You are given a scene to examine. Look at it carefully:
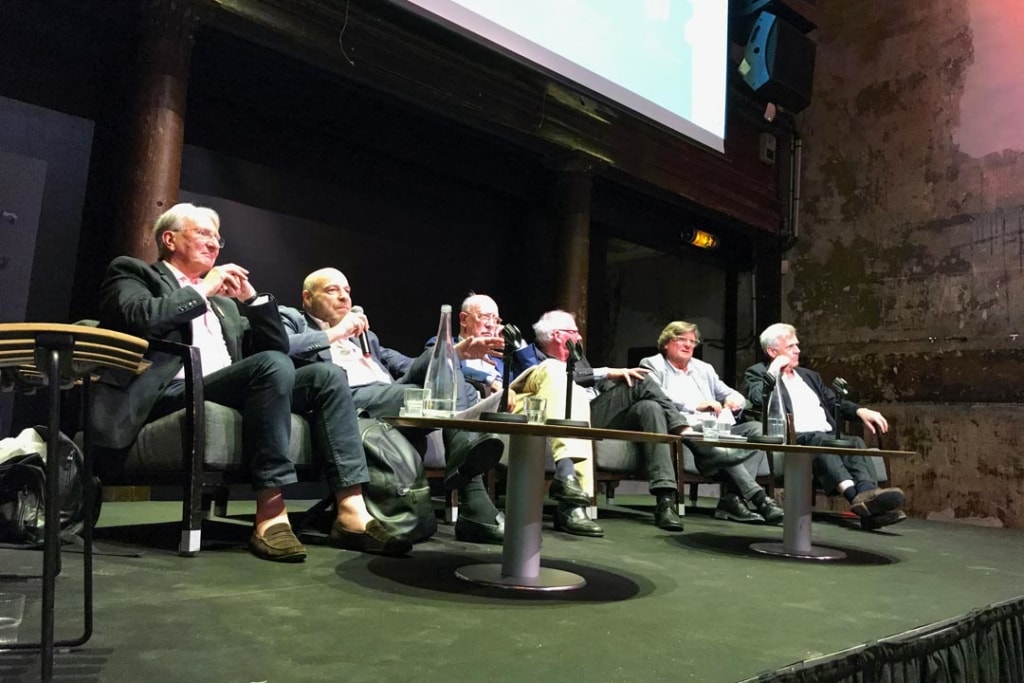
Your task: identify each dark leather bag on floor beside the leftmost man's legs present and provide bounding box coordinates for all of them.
[359,418,437,543]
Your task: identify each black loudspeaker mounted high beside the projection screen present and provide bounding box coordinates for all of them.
[740,12,816,112]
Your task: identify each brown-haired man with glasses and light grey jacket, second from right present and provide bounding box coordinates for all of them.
[640,321,782,524]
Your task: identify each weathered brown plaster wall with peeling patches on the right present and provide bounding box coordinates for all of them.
[783,0,1024,527]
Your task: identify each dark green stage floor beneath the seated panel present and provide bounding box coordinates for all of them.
[0,497,1024,683]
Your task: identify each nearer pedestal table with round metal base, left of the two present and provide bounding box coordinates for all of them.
[384,417,679,591]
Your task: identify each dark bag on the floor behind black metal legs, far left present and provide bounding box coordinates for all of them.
[0,426,98,546]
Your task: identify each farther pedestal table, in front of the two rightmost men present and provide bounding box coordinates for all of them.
[683,434,915,560]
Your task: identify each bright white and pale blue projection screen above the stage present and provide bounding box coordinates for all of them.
[394,0,728,152]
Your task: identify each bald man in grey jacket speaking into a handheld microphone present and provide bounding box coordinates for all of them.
[280,268,505,544]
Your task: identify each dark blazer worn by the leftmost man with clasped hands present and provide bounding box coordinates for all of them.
[92,256,288,449]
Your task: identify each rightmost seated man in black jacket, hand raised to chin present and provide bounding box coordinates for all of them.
[745,323,906,529]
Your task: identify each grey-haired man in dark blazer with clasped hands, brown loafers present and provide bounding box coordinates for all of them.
[92,204,411,561]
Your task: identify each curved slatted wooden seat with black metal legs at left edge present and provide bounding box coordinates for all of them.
[0,323,150,681]
